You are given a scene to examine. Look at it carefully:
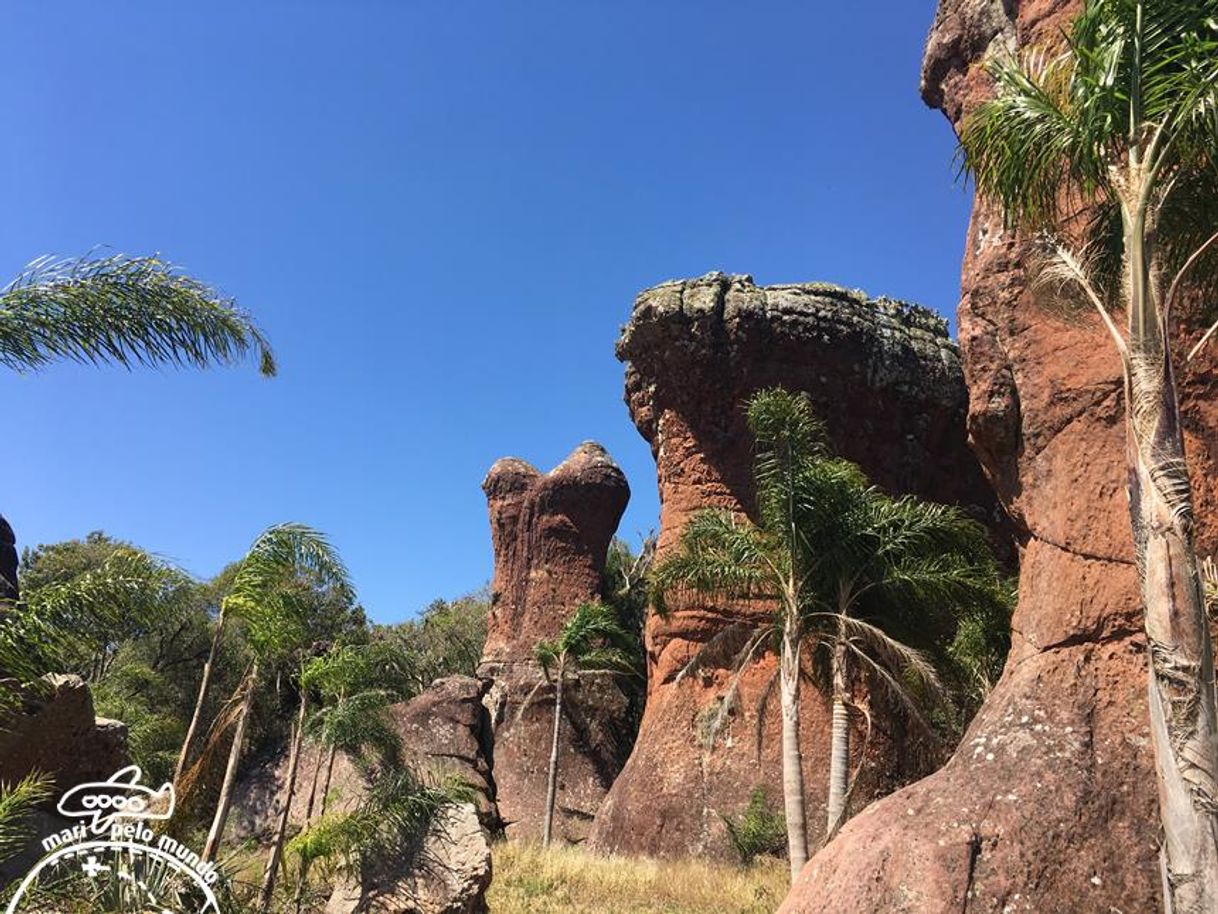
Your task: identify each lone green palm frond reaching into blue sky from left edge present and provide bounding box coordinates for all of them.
[0,255,275,377]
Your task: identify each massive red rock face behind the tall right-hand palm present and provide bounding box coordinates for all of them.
[782,0,1218,914]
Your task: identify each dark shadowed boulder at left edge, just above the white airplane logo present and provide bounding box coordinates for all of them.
[0,673,130,792]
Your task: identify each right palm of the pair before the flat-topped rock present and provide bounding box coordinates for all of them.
[800,473,1002,841]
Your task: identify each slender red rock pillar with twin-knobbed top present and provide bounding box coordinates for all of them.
[479,441,630,841]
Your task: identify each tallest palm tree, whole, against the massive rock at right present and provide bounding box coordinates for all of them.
[960,0,1218,912]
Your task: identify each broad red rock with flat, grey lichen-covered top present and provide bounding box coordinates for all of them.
[592,273,1001,856]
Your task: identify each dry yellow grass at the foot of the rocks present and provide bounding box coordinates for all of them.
[487,842,788,914]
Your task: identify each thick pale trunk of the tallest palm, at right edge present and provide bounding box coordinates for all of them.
[1125,339,1218,914]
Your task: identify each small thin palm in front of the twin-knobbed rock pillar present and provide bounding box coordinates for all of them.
[531,603,632,847]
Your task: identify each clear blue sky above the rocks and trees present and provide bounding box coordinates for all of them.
[0,0,968,622]
